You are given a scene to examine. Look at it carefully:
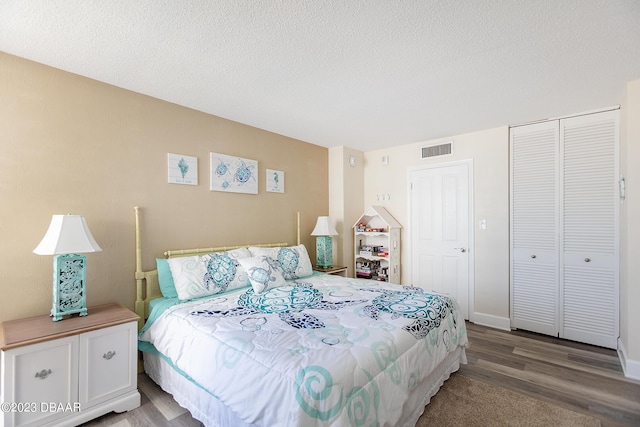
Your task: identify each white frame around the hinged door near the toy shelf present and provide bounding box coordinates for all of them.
[407,159,475,322]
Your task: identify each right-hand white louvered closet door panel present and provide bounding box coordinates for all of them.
[560,111,619,348]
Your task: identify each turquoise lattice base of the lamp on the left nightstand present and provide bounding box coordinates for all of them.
[51,254,87,321]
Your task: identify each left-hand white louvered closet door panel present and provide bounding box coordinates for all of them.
[510,121,560,336]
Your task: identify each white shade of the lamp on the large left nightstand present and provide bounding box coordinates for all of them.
[33,215,102,255]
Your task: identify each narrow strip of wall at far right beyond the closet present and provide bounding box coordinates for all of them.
[619,80,640,380]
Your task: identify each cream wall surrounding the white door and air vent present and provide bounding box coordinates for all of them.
[356,127,509,328]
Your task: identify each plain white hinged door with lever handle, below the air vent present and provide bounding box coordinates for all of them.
[410,164,470,319]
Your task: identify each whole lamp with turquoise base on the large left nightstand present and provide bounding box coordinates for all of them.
[33,215,102,321]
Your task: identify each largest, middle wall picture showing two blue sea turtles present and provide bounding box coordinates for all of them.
[210,153,258,194]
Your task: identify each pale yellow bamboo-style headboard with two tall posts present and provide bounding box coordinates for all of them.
[133,206,300,329]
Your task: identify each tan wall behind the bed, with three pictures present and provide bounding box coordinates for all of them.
[0,53,329,320]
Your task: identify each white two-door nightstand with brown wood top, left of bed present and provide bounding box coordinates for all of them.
[0,304,140,427]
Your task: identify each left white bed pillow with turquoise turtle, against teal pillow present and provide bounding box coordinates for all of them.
[168,248,251,300]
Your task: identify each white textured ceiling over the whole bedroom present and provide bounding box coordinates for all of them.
[0,0,640,151]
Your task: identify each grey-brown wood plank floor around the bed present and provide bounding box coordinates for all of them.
[85,323,640,427]
